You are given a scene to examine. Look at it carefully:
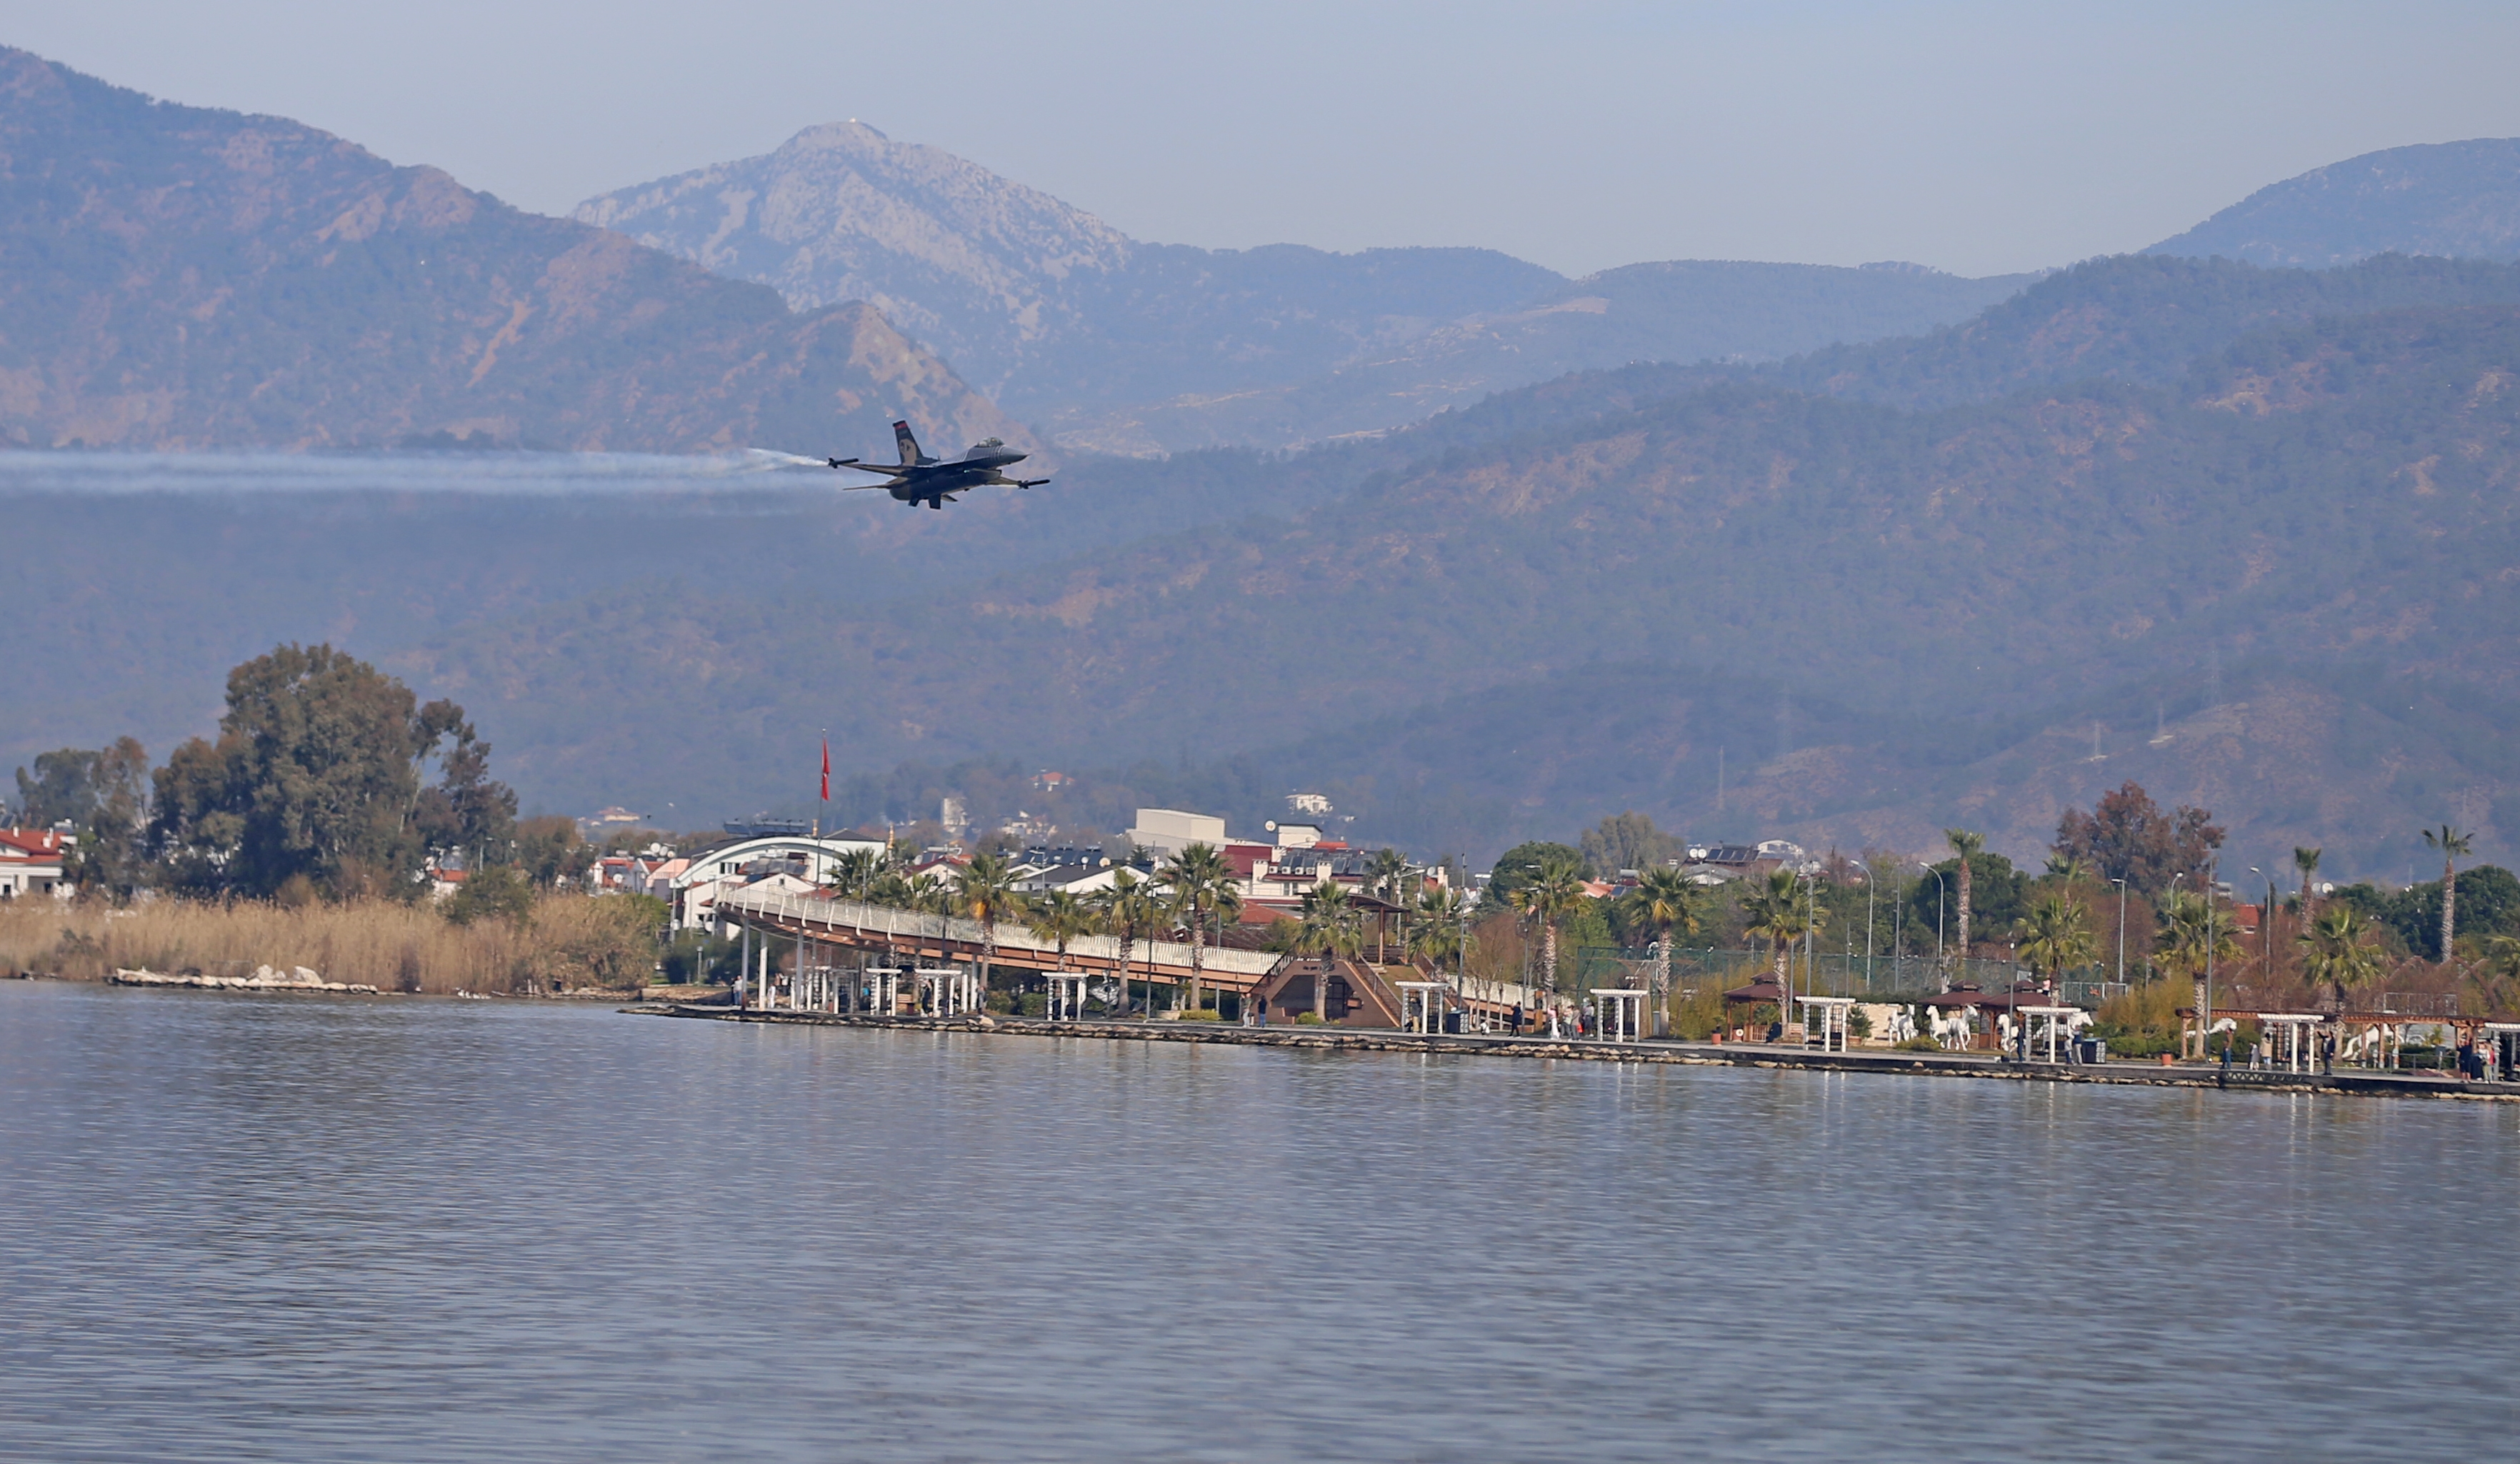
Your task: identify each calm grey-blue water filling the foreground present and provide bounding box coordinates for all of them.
[0,983,2520,1461]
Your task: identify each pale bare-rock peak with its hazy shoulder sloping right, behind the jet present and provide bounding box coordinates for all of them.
[574,121,1560,413]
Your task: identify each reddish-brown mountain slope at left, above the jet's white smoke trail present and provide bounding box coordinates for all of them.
[0,51,1023,451]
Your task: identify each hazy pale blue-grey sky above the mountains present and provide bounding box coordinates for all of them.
[0,0,2520,275]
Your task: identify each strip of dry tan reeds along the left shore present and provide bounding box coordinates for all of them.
[0,895,655,996]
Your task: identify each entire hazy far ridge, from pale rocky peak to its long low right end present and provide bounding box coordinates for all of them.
[574,121,2031,456]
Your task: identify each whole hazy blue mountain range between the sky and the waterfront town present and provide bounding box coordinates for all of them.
[0,40,2520,877]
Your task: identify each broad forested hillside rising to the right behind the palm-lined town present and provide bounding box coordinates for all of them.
[360,294,2520,857]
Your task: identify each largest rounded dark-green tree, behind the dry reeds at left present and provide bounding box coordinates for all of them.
[149,645,514,897]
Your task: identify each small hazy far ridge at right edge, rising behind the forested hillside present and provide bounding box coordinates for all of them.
[2144,136,2520,270]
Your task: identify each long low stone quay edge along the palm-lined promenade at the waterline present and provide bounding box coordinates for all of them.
[622,1003,2520,1103]
